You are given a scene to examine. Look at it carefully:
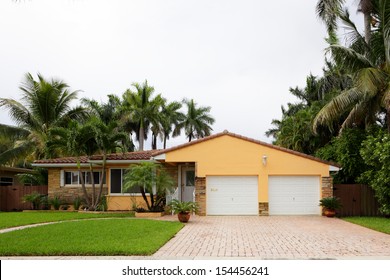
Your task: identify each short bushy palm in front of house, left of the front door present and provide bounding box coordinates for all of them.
[124,162,175,211]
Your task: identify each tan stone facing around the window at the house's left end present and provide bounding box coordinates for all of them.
[48,168,107,204]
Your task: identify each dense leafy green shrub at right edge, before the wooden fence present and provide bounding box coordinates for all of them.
[360,130,390,215]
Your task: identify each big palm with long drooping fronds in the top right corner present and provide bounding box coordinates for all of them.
[313,0,390,131]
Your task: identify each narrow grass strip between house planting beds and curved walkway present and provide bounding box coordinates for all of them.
[0,211,134,229]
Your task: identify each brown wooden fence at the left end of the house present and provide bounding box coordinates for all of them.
[0,186,47,211]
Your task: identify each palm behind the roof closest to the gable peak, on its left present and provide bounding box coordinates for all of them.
[179,99,215,142]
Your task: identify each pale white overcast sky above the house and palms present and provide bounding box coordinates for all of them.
[0,0,362,148]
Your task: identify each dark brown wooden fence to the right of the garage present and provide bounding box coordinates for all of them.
[333,184,381,217]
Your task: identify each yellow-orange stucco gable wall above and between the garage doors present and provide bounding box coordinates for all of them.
[165,135,329,202]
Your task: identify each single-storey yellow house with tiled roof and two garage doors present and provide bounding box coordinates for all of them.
[34,131,339,215]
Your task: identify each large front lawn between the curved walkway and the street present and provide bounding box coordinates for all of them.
[0,218,183,256]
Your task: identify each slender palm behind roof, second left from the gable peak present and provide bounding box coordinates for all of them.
[161,101,185,149]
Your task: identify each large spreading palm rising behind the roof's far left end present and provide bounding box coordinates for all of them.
[0,73,86,159]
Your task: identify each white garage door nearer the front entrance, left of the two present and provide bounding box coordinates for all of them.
[206,176,259,215]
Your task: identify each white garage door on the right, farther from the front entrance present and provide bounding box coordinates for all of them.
[268,176,321,215]
